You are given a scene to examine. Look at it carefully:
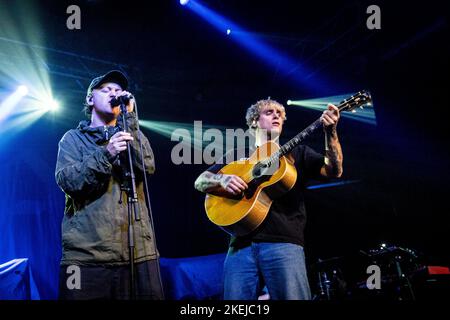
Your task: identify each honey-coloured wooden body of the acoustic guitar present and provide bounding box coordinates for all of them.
[205,141,297,236]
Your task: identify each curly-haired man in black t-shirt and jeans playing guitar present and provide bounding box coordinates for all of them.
[195,99,343,300]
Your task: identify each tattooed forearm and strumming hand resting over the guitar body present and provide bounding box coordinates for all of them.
[195,171,248,197]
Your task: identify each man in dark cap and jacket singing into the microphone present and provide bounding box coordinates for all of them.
[55,70,163,300]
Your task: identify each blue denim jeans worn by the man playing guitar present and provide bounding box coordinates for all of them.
[224,242,311,300]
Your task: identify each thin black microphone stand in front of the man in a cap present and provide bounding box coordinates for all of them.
[120,101,141,300]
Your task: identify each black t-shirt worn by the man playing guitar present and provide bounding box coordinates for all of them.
[207,145,324,247]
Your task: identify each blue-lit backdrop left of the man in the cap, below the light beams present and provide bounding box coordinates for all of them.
[0,128,64,299]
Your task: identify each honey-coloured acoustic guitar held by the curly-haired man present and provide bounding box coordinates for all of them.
[205,91,372,236]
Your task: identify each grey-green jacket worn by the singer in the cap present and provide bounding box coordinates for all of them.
[55,113,157,265]
